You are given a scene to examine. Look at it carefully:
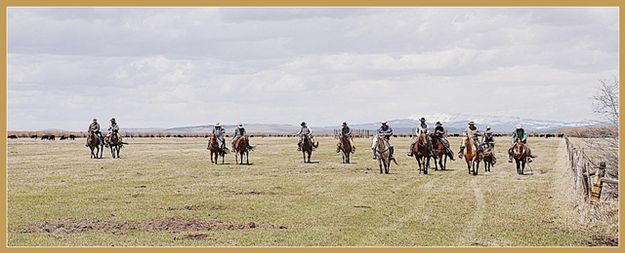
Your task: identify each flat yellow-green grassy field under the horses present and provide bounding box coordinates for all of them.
[8,138,617,246]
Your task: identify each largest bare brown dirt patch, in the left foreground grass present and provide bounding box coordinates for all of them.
[21,217,286,234]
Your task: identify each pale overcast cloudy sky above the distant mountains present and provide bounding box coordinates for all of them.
[7,8,618,130]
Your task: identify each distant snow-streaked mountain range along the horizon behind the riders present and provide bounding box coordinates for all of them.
[121,113,602,134]
